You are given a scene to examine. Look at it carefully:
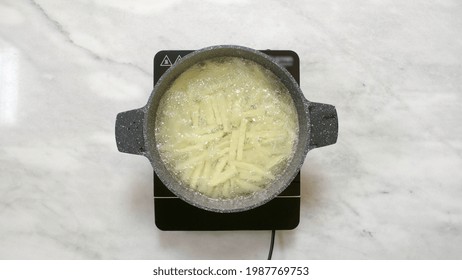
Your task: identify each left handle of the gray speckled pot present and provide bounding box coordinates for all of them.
[115,108,146,155]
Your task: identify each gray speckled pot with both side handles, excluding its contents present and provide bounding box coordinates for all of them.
[115,46,338,212]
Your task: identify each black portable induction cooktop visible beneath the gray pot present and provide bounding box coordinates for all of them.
[154,50,300,231]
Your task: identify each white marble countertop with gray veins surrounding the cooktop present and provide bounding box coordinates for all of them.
[0,0,462,259]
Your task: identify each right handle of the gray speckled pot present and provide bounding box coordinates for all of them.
[306,101,338,149]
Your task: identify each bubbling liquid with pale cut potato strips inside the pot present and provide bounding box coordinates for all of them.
[155,57,298,199]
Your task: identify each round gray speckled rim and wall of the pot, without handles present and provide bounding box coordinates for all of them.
[143,45,310,213]
